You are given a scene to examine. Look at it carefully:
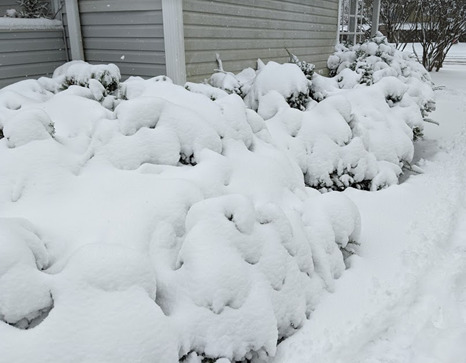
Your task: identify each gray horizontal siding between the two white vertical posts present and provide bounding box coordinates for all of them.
[73,0,165,78]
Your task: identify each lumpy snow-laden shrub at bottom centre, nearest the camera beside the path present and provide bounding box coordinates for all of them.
[152,195,359,361]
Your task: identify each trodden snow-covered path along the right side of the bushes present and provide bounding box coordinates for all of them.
[274,65,466,363]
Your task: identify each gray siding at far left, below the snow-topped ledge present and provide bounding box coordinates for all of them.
[0,29,66,87]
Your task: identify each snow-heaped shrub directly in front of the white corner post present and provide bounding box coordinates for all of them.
[103,81,253,168]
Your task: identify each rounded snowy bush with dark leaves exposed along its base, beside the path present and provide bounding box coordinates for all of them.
[267,86,413,191]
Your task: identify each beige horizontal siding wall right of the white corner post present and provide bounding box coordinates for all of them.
[183,0,338,81]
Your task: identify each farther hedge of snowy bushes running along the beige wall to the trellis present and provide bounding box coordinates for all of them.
[204,35,435,191]
